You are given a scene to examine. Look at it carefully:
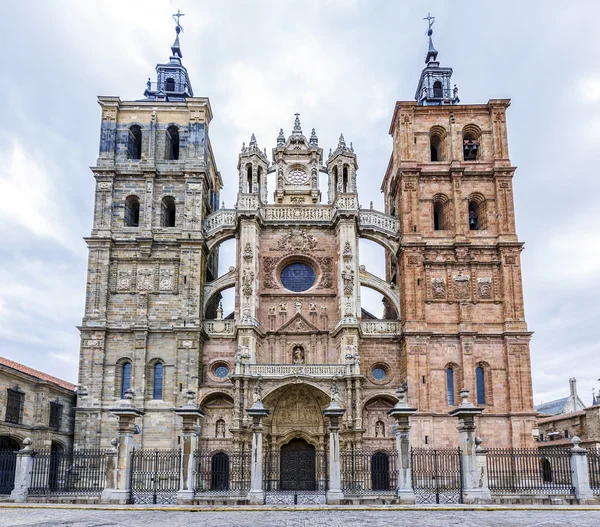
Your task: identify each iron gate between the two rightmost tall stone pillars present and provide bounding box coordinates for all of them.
[411,448,463,503]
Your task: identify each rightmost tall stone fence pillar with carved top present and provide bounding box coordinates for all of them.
[450,388,492,503]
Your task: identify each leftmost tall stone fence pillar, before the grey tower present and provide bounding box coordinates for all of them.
[108,390,144,504]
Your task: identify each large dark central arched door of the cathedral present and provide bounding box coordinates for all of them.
[280,439,317,490]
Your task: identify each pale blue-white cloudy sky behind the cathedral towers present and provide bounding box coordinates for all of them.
[0,0,600,403]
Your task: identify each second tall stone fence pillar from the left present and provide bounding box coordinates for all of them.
[175,390,205,503]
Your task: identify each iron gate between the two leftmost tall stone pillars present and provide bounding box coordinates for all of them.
[131,448,181,505]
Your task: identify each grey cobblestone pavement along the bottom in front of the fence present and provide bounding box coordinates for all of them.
[0,507,600,527]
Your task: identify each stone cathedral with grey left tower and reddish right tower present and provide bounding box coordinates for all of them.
[75,18,535,450]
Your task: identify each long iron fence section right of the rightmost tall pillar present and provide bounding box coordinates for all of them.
[487,448,575,494]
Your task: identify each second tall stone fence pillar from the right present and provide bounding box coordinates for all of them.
[388,384,417,503]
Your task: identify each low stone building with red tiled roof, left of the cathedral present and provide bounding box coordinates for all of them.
[0,357,76,450]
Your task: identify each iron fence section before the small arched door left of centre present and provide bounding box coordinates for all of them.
[194,450,252,496]
